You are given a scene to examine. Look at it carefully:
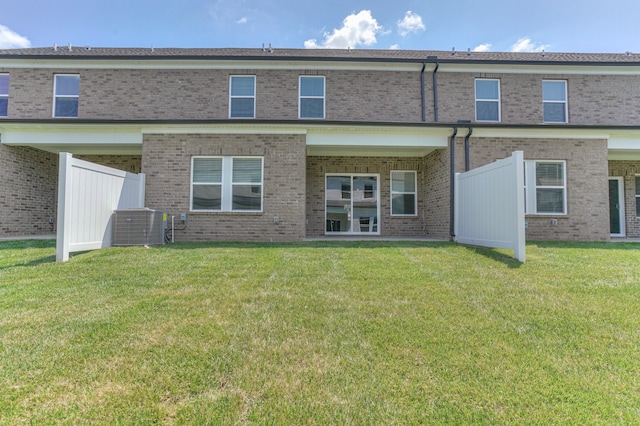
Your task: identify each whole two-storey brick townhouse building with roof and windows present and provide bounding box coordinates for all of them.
[0,46,640,241]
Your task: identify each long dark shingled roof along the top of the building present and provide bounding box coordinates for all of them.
[0,45,640,65]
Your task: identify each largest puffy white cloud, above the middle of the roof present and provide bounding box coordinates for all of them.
[304,10,383,49]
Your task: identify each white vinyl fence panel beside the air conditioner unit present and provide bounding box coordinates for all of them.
[56,152,145,262]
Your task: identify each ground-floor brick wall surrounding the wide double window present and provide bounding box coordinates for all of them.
[142,134,306,241]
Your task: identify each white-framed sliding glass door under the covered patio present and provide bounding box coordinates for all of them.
[325,174,380,234]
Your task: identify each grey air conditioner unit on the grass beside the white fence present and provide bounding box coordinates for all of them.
[113,208,167,246]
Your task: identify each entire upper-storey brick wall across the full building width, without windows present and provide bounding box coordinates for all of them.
[6,68,640,125]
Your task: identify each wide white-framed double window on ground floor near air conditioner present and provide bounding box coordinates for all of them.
[191,157,263,212]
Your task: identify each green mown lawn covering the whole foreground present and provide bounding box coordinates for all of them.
[0,241,640,425]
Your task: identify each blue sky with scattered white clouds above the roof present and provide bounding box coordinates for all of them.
[0,0,640,53]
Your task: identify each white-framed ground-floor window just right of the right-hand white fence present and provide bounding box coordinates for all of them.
[524,160,567,215]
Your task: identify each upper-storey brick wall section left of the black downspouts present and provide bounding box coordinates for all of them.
[0,69,422,121]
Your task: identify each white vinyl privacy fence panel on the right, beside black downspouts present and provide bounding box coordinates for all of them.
[454,151,525,262]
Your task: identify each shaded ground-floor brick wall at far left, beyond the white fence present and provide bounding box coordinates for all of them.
[0,144,58,237]
